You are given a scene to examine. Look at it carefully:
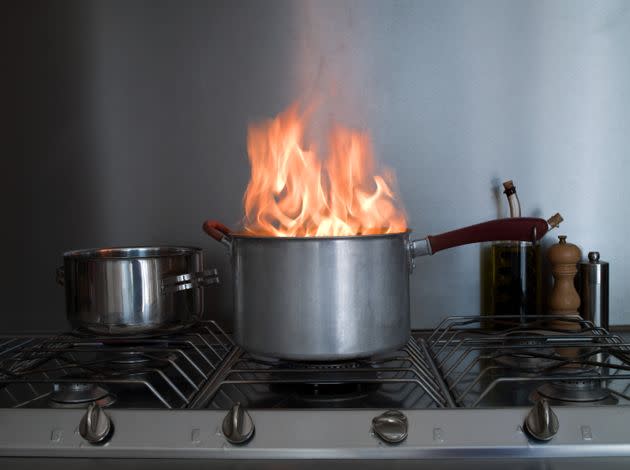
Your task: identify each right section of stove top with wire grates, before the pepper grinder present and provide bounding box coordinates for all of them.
[426,316,630,408]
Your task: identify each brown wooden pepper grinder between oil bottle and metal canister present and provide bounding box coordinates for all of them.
[547,235,582,331]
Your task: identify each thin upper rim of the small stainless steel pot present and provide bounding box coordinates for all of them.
[63,245,202,260]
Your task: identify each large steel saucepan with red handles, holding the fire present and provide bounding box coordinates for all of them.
[203,218,548,361]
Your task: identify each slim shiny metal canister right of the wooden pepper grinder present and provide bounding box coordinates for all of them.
[580,251,609,329]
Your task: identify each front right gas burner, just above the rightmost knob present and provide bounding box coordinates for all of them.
[531,369,619,405]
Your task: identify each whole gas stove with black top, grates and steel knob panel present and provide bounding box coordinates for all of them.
[0,316,630,468]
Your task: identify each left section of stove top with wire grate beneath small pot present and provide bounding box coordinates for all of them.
[0,322,234,408]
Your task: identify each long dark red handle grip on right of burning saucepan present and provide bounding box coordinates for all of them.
[427,217,548,253]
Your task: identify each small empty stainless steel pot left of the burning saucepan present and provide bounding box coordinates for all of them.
[57,246,219,335]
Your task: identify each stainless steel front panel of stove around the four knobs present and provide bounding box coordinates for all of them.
[6,406,630,460]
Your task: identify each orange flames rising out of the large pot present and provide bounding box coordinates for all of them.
[244,104,407,237]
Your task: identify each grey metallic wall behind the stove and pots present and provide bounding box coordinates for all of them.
[0,0,630,331]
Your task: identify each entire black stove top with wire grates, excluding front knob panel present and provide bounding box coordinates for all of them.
[0,316,630,410]
